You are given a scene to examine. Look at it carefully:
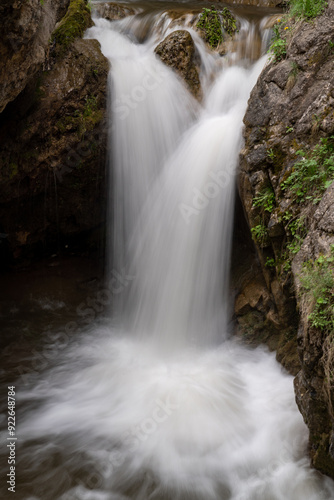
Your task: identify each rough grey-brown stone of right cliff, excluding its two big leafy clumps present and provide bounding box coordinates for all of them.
[237,1,334,478]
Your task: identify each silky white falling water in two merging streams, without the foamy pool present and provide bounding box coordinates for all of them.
[85,14,264,351]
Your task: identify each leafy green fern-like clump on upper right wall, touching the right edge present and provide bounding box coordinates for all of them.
[281,136,334,204]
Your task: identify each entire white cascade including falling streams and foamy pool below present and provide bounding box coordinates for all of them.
[3,4,334,500]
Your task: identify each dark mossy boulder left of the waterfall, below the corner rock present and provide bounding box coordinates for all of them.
[0,2,109,266]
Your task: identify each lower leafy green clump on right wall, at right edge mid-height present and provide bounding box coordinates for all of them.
[300,245,334,333]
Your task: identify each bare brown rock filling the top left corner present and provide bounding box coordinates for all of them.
[0,0,70,113]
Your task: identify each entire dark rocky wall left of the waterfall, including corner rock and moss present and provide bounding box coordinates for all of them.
[0,0,109,266]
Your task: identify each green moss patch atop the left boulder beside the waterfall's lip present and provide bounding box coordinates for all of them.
[51,0,92,57]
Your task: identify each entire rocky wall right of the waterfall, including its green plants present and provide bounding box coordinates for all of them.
[236,1,334,478]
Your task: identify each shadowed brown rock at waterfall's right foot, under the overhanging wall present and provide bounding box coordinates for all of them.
[231,195,301,375]
